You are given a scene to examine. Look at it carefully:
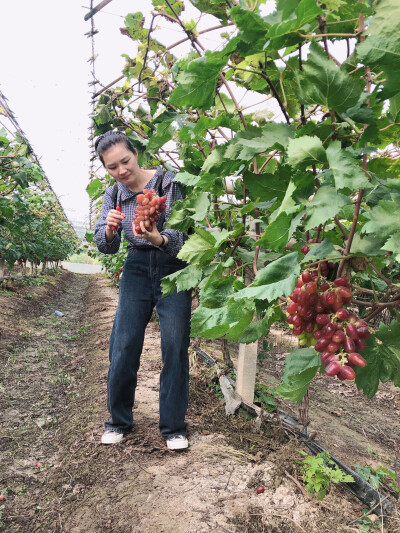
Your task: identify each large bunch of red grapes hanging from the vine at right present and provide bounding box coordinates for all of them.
[287,270,370,380]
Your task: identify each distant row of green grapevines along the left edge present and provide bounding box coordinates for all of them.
[0,108,79,278]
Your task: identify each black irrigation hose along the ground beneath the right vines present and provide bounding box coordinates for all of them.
[194,346,393,515]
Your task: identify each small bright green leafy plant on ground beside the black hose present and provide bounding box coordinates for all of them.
[300,450,354,501]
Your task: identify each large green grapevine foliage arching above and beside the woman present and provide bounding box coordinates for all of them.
[88,0,400,400]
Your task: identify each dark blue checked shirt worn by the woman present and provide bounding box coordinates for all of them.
[94,168,187,257]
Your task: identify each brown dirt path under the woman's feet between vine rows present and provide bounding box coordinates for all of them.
[0,272,396,533]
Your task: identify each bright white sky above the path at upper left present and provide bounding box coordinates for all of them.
[0,0,288,229]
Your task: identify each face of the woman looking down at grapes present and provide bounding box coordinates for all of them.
[102,143,139,188]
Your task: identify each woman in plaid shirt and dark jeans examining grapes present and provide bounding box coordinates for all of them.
[94,132,191,450]
